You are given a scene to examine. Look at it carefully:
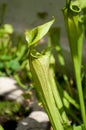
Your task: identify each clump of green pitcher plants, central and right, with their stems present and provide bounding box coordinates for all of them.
[26,0,86,130]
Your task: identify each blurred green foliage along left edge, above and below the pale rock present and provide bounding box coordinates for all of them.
[0,4,32,130]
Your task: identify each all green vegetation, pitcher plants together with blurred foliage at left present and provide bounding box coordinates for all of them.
[0,0,86,130]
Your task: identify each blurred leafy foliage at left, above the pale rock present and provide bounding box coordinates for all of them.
[0,24,30,89]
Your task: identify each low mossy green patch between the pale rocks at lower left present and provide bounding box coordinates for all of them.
[0,100,29,120]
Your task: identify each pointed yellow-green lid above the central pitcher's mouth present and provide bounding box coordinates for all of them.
[26,19,55,47]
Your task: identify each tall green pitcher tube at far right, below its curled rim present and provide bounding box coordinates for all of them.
[63,2,86,128]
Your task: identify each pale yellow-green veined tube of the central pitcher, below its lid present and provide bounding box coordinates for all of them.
[30,50,64,130]
